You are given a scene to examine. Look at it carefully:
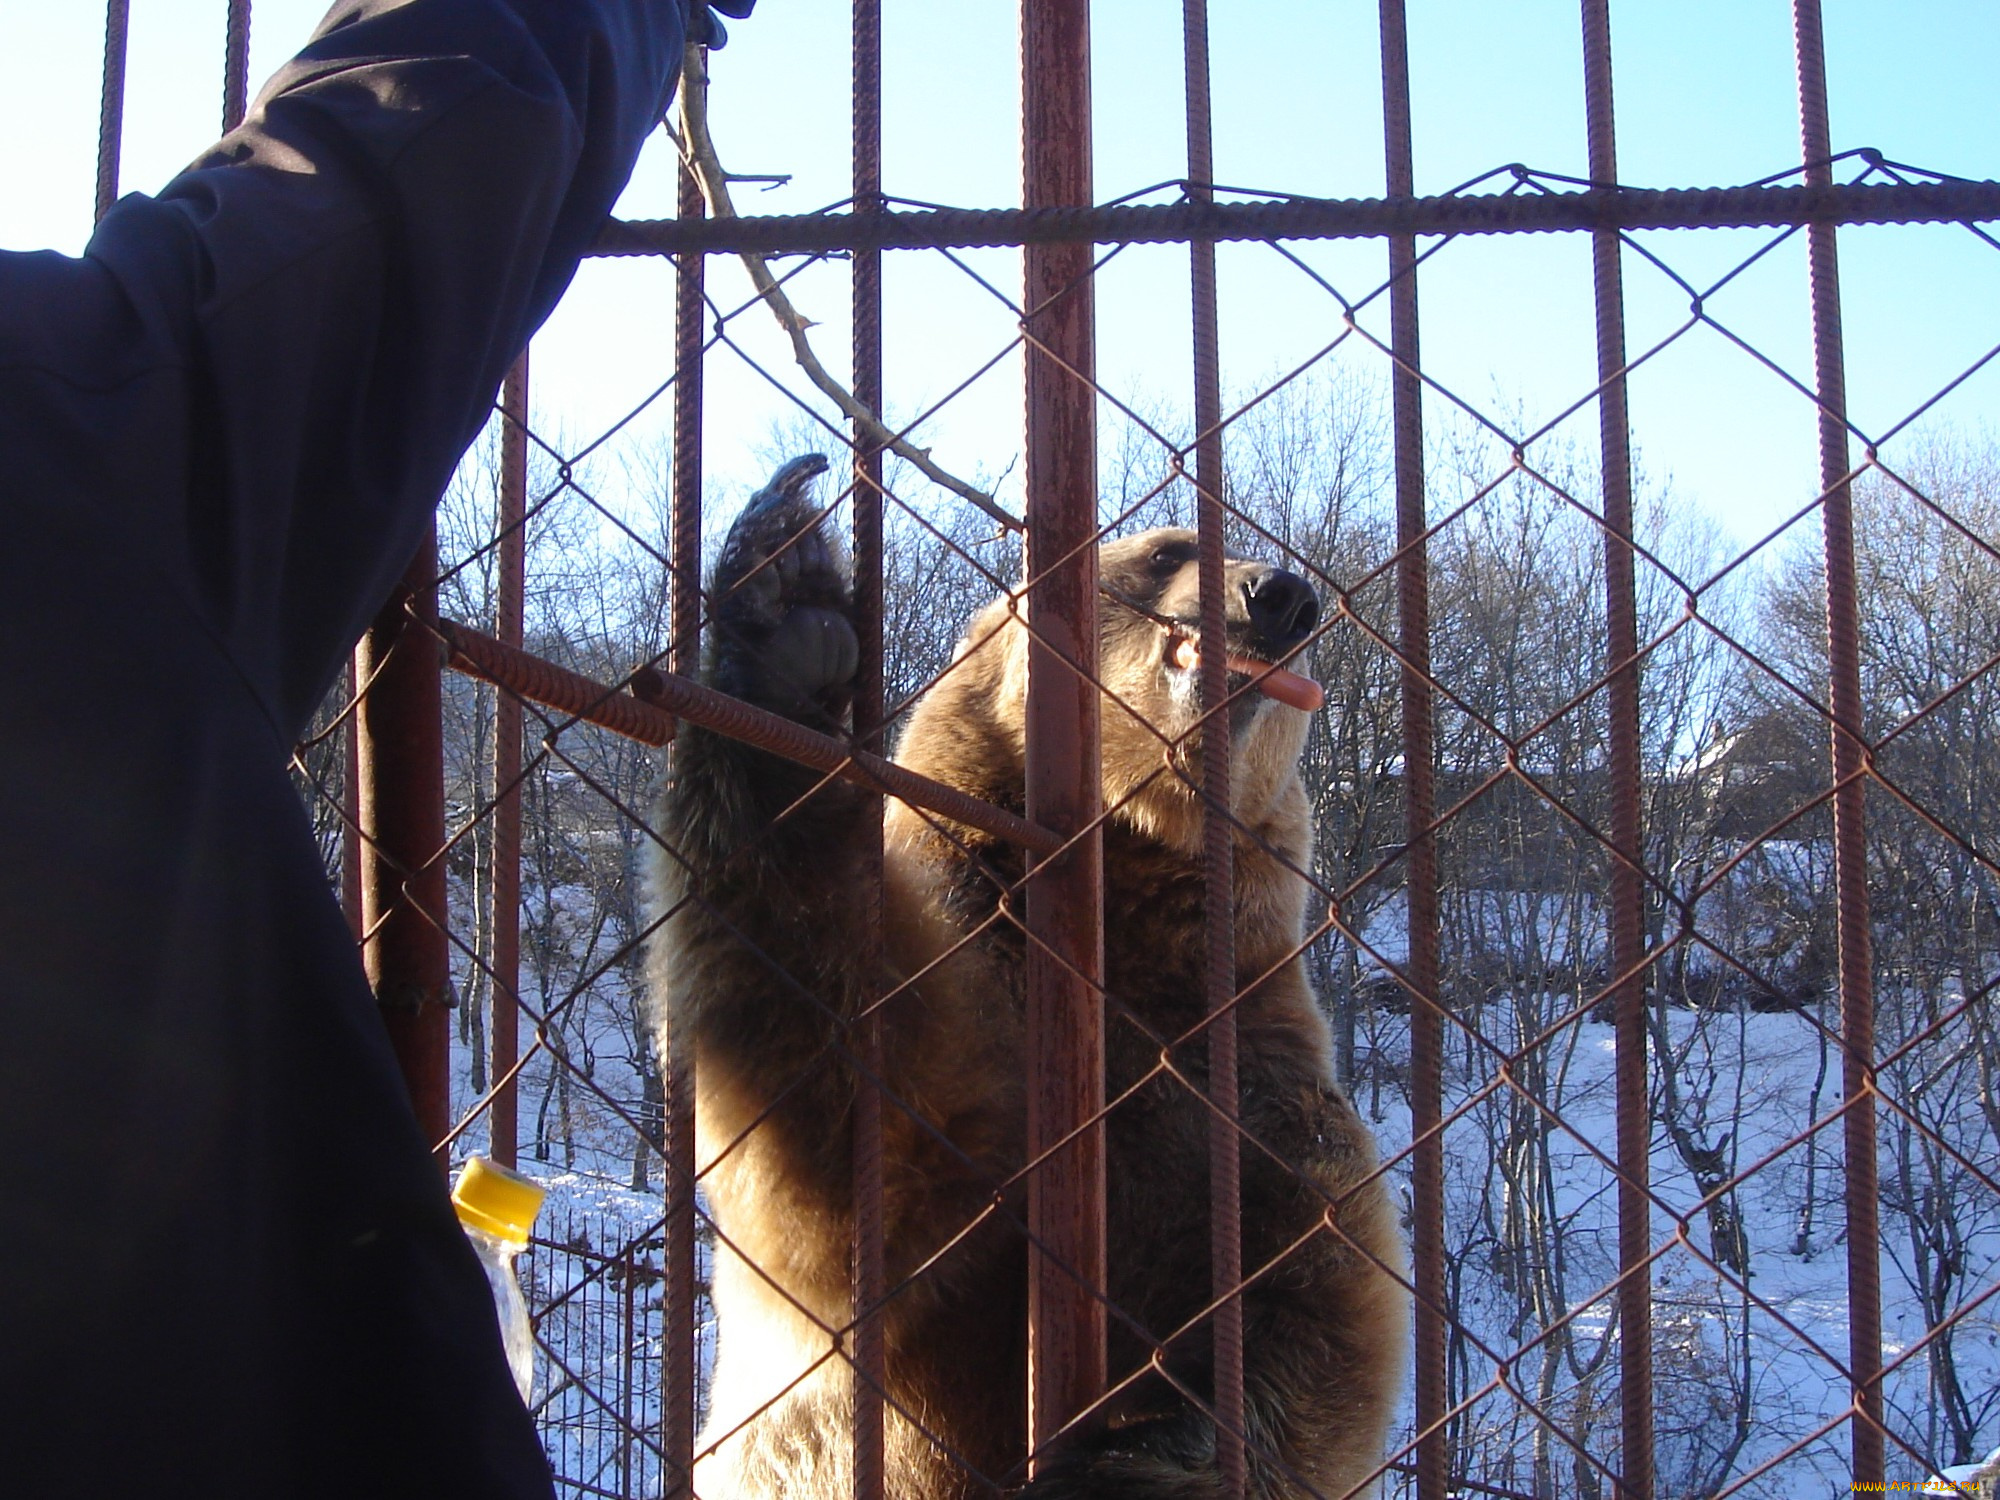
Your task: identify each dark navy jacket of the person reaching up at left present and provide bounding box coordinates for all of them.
[0,0,684,1500]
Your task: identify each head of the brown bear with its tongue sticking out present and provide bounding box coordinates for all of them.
[898,528,1320,852]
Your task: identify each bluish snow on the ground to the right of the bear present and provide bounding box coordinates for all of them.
[1356,996,2000,1496]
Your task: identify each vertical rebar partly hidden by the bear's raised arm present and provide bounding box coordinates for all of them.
[660,114,706,1500]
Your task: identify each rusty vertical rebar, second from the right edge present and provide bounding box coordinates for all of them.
[1584,0,1654,1500]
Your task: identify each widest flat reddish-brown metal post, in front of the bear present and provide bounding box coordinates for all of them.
[1020,0,1106,1470]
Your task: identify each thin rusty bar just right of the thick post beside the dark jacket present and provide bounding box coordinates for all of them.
[486,350,528,1166]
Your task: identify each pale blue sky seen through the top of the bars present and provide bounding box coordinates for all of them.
[0,0,2000,560]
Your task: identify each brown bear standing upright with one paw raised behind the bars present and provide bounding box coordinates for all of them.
[650,456,1408,1500]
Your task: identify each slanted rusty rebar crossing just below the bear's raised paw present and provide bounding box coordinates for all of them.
[436,620,1062,854]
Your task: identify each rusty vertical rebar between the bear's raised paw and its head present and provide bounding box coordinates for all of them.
[852,0,888,1500]
